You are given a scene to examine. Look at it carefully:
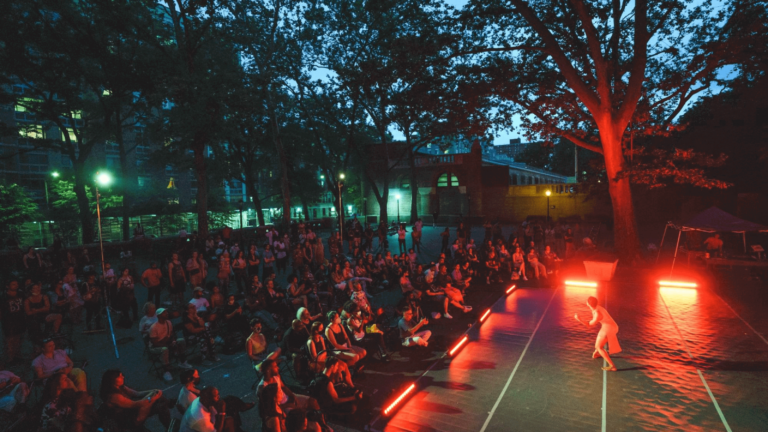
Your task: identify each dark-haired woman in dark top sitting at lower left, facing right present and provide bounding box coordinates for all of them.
[99,369,171,429]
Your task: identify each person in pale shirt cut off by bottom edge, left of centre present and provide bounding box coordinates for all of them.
[179,387,235,432]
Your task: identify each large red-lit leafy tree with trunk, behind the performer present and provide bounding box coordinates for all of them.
[456,0,750,262]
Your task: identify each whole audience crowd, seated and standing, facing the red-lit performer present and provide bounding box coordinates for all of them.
[0,218,591,432]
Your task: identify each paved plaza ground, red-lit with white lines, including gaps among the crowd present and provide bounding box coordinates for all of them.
[6,227,768,431]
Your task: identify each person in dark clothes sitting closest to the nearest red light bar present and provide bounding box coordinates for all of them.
[309,356,363,415]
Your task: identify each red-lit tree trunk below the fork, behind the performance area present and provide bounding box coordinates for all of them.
[600,124,640,264]
